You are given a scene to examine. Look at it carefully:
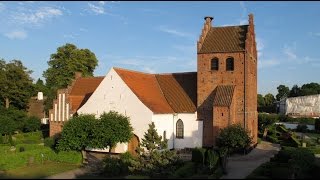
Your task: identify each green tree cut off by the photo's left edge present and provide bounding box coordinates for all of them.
[0,59,33,109]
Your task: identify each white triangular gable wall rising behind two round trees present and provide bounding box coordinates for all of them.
[77,68,153,153]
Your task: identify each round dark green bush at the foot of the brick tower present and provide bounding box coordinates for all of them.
[217,124,252,153]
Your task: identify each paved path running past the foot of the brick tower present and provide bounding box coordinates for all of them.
[221,141,280,179]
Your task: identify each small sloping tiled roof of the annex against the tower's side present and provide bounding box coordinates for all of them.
[213,85,235,106]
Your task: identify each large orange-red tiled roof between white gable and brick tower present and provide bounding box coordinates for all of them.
[114,68,197,114]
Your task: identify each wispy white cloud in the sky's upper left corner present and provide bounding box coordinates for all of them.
[13,7,63,25]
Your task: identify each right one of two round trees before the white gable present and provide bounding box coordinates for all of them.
[91,111,133,152]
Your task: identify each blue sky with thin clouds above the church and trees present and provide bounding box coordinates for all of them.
[0,1,320,95]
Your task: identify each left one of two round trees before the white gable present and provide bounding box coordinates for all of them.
[57,115,96,151]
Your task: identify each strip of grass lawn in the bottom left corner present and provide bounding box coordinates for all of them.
[0,161,80,179]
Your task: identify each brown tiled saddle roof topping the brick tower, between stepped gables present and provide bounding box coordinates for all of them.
[198,25,248,53]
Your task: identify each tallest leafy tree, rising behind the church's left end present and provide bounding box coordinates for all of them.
[43,43,98,112]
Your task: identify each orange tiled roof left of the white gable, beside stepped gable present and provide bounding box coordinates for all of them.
[69,77,104,112]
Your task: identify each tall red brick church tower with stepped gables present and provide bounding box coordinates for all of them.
[197,14,258,147]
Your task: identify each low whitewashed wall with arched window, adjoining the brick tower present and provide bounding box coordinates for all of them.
[152,113,203,149]
